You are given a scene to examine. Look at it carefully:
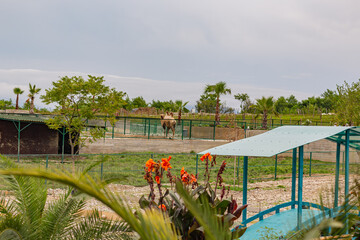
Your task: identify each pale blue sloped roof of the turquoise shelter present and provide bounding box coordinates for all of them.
[199,126,360,157]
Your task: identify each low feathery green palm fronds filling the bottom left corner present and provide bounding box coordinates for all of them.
[0,172,129,240]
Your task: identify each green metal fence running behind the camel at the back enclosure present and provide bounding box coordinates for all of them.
[84,117,331,140]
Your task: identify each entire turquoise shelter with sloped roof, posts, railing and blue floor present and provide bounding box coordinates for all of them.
[199,126,360,240]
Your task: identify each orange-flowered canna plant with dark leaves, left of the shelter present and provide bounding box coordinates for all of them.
[139,155,247,239]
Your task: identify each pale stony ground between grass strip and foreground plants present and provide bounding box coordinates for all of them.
[43,172,355,221]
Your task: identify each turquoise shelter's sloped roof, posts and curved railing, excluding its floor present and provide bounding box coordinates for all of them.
[199,126,360,237]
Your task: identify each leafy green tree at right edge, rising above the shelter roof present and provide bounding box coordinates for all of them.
[336,80,360,126]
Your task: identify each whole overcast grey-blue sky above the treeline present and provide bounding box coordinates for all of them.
[0,0,360,109]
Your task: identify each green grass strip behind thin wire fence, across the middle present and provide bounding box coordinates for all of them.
[0,152,358,189]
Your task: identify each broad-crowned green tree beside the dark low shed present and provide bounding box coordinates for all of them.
[41,75,124,168]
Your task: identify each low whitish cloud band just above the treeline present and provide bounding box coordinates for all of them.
[0,69,310,108]
